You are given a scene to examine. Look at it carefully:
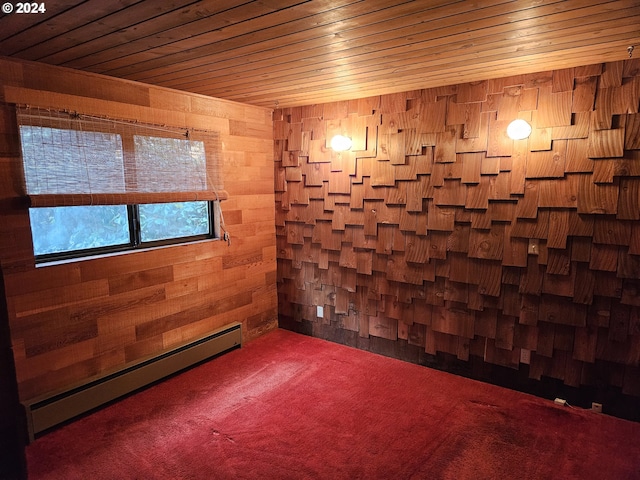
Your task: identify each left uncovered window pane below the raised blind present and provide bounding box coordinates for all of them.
[29,205,130,255]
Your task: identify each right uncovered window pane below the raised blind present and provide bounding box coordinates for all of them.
[139,201,210,242]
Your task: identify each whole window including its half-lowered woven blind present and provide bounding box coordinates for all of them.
[18,109,224,262]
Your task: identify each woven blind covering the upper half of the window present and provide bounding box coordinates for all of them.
[17,107,226,207]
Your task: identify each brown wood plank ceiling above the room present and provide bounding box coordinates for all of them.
[0,0,640,108]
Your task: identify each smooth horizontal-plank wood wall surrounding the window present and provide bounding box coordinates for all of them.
[0,59,277,400]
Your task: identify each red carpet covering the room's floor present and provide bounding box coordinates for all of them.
[27,330,640,480]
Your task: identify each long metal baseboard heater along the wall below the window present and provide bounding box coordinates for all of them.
[23,322,242,441]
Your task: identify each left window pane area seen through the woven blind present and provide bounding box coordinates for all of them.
[20,125,125,195]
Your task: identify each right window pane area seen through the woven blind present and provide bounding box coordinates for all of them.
[133,135,207,192]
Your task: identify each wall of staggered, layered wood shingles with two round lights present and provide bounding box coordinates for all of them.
[274,59,640,396]
